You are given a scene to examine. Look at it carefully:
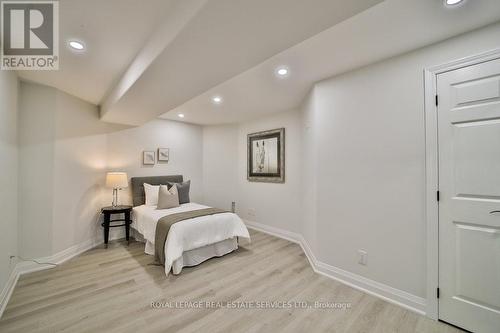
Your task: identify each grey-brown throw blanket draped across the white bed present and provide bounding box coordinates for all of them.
[155,208,227,266]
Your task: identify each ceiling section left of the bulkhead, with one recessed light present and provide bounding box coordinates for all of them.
[18,0,173,104]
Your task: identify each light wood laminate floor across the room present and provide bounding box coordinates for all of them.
[0,231,459,333]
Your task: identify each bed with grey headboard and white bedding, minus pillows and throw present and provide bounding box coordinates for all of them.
[131,175,250,276]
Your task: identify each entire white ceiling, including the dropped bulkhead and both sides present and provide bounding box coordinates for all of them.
[13,0,500,125]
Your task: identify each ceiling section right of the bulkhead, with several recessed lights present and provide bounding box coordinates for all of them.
[161,0,500,125]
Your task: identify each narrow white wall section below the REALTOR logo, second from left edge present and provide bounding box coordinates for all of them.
[18,82,57,258]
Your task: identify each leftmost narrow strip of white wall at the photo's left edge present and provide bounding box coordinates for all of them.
[0,71,18,292]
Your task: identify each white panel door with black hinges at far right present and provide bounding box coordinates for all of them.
[437,60,500,333]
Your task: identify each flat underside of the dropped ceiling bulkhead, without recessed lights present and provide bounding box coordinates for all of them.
[101,0,381,125]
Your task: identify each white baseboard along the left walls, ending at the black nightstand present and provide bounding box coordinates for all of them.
[0,235,127,318]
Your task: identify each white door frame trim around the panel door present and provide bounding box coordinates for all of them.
[424,49,500,320]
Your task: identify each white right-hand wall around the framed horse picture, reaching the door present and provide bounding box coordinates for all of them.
[203,24,500,298]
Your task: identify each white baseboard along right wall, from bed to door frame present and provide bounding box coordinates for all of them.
[245,220,426,315]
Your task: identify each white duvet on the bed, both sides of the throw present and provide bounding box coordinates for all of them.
[132,202,250,275]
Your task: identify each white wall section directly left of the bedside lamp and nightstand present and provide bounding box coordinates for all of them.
[52,91,112,253]
